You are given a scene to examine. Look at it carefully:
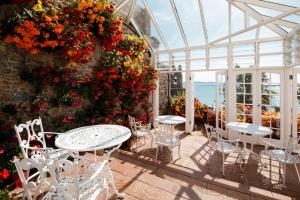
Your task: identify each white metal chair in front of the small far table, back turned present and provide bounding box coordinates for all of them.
[155,124,181,162]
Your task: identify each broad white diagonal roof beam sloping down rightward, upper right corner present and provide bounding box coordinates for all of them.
[231,2,287,38]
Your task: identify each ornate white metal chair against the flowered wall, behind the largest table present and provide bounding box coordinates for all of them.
[15,117,68,160]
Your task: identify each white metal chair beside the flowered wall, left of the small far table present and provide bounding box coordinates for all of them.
[128,115,153,150]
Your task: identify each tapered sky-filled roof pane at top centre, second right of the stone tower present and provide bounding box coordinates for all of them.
[174,0,205,46]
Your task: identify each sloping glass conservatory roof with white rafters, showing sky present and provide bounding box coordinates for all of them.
[114,0,300,51]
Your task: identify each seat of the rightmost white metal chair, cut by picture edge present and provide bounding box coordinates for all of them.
[260,149,300,164]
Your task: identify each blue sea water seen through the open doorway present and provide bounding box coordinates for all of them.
[194,82,216,107]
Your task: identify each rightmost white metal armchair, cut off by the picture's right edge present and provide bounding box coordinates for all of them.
[259,136,300,185]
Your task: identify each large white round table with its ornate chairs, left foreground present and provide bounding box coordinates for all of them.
[14,118,131,200]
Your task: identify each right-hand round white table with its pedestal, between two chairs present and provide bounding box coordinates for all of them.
[227,122,272,159]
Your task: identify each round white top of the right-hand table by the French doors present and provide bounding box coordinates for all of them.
[227,122,272,136]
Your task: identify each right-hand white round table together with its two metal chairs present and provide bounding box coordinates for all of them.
[205,122,300,184]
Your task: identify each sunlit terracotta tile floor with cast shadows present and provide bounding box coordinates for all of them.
[9,126,300,200]
